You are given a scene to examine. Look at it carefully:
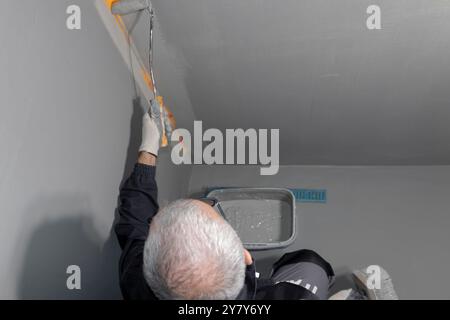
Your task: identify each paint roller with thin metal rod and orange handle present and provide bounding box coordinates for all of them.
[111,0,175,147]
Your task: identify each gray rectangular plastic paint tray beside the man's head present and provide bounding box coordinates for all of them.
[207,188,296,250]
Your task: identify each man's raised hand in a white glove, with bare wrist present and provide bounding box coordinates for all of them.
[138,112,160,165]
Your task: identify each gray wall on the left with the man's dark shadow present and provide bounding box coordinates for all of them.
[0,0,193,299]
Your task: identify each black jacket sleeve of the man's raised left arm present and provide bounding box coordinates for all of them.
[115,164,158,299]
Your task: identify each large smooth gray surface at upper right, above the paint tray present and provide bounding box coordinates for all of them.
[148,0,450,165]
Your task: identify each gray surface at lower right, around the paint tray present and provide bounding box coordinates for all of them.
[190,166,450,299]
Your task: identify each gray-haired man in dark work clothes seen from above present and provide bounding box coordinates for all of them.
[115,113,334,299]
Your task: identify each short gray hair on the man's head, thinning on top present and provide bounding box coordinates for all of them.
[144,200,245,300]
